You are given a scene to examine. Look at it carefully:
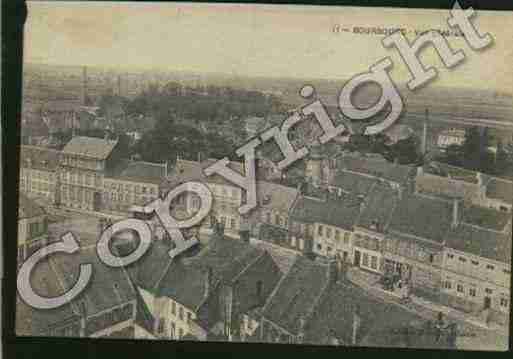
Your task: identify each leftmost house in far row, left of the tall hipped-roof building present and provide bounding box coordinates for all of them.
[19,145,59,204]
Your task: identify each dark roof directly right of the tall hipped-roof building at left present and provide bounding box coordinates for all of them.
[108,160,166,184]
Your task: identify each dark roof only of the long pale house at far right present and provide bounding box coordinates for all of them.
[446,223,511,263]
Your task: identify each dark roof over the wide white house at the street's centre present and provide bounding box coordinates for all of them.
[291,196,360,230]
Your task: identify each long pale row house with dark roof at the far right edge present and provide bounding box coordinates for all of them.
[441,205,511,324]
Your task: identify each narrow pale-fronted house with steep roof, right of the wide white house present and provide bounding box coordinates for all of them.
[350,183,400,274]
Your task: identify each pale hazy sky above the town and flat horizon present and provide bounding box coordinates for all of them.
[25,2,513,93]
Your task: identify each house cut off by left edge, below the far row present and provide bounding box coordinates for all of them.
[18,193,48,265]
